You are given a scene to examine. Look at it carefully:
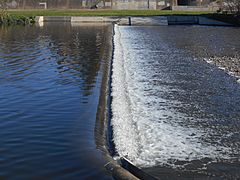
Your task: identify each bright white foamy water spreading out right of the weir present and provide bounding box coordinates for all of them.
[112,26,231,167]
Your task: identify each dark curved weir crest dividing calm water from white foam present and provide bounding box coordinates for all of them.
[95,22,157,180]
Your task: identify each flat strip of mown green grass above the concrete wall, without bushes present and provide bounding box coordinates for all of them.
[8,9,211,17]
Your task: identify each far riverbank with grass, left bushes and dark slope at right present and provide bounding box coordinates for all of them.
[5,9,240,26]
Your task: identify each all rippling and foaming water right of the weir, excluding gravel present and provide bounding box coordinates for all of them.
[112,26,240,177]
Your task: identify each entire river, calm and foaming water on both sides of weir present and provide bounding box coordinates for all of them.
[0,23,240,179]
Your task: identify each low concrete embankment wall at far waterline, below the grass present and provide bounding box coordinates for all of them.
[36,15,231,26]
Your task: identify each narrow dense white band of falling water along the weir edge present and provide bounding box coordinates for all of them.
[112,25,138,160]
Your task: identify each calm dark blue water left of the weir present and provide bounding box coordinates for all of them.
[0,24,109,179]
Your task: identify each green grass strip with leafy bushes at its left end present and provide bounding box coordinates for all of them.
[0,10,208,25]
